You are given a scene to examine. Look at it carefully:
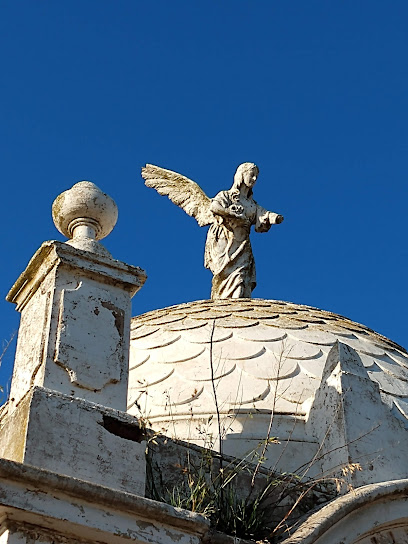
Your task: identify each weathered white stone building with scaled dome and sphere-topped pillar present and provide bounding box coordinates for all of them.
[0,182,408,544]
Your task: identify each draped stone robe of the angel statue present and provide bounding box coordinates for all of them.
[204,190,278,299]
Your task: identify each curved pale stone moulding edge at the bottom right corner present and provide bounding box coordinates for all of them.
[281,479,408,544]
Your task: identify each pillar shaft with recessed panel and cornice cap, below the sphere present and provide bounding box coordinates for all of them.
[8,242,146,410]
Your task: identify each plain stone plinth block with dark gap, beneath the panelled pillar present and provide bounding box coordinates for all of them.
[0,387,146,496]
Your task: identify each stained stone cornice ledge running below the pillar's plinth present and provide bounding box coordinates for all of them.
[0,459,209,544]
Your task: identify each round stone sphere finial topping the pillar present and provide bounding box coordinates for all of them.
[52,181,118,256]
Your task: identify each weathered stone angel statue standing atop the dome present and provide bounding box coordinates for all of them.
[142,162,283,299]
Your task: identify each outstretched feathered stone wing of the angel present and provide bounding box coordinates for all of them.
[142,164,214,227]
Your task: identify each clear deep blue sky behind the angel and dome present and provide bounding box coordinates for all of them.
[0,0,408,398]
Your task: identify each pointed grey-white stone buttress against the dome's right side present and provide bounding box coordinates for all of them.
[306,342,408,486]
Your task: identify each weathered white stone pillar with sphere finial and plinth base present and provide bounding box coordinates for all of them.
[0,181,146,495]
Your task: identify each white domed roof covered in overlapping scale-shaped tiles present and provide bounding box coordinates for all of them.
[129,299,408,421]
